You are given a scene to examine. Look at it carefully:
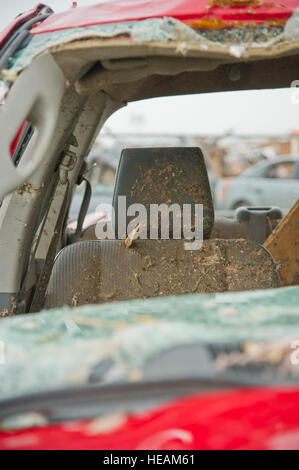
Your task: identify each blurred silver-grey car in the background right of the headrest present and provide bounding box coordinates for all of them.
[215,156,299,209]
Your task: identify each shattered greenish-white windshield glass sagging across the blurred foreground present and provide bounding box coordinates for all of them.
[0,287,299,399]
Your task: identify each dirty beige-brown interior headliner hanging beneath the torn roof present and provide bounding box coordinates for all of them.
[50,39,299,102]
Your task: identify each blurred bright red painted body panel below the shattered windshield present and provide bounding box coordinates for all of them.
[0,388,299,450]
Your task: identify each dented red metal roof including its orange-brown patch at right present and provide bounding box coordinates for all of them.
[33,0,298,34]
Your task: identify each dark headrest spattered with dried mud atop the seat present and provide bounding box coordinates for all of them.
[113,147,214,238]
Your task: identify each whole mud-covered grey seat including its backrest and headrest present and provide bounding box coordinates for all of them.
[45,148,279,308]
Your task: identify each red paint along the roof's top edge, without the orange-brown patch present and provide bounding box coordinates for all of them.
[32,0,298,34]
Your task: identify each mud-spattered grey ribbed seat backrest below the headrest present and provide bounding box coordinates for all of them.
[45,240,279,309]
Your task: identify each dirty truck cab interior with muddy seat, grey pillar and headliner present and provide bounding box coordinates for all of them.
[0,23,298,316]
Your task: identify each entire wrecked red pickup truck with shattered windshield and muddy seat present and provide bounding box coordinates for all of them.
[0,0,299,450]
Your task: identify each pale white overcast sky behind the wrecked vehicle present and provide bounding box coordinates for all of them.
[0,0,299,134]
